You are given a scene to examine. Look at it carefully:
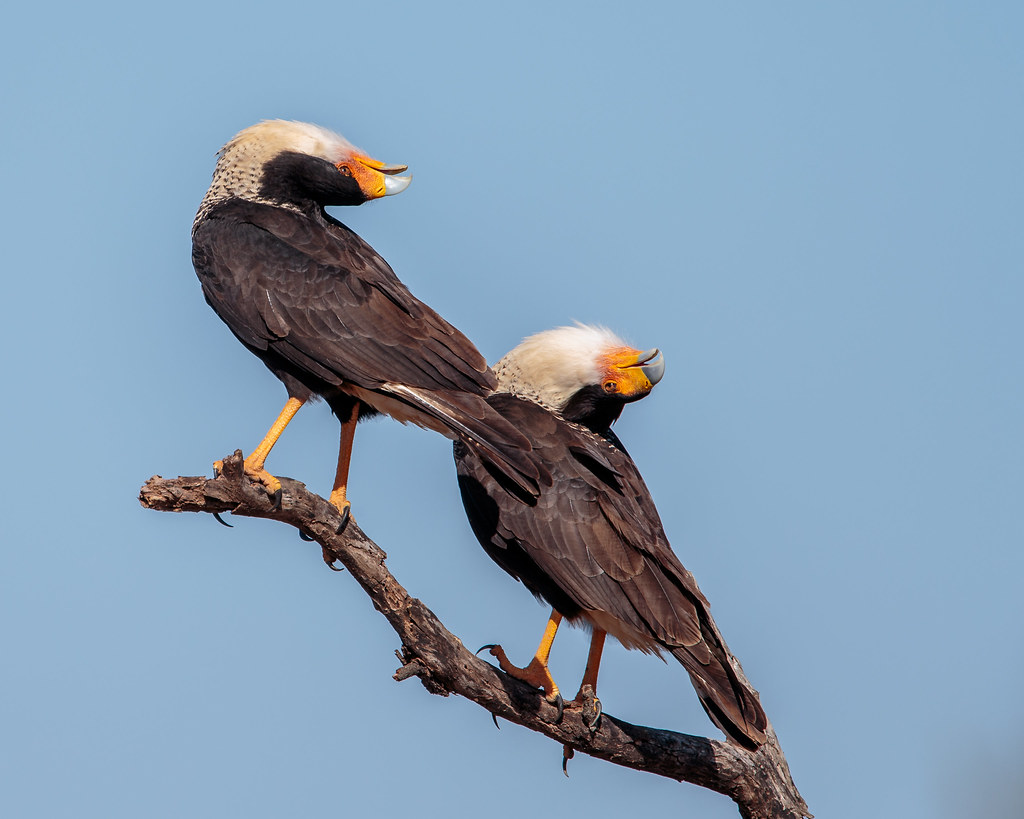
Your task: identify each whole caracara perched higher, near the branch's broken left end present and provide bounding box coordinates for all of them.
[193,120,537,525]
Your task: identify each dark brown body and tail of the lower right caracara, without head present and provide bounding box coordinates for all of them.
[456,395,767,747]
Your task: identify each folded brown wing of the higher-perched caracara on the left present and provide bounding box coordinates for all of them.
[193,201,495,395]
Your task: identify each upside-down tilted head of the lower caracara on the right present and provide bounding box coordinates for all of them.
[495,325,665,430]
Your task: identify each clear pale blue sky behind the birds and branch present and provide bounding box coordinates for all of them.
[0,0,1024,819]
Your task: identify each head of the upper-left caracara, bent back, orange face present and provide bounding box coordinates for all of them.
[208,120,413,206]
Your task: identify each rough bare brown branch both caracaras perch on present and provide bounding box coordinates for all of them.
[139,450,811,819]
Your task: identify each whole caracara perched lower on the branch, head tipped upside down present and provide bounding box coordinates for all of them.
[455,325,768,751]
